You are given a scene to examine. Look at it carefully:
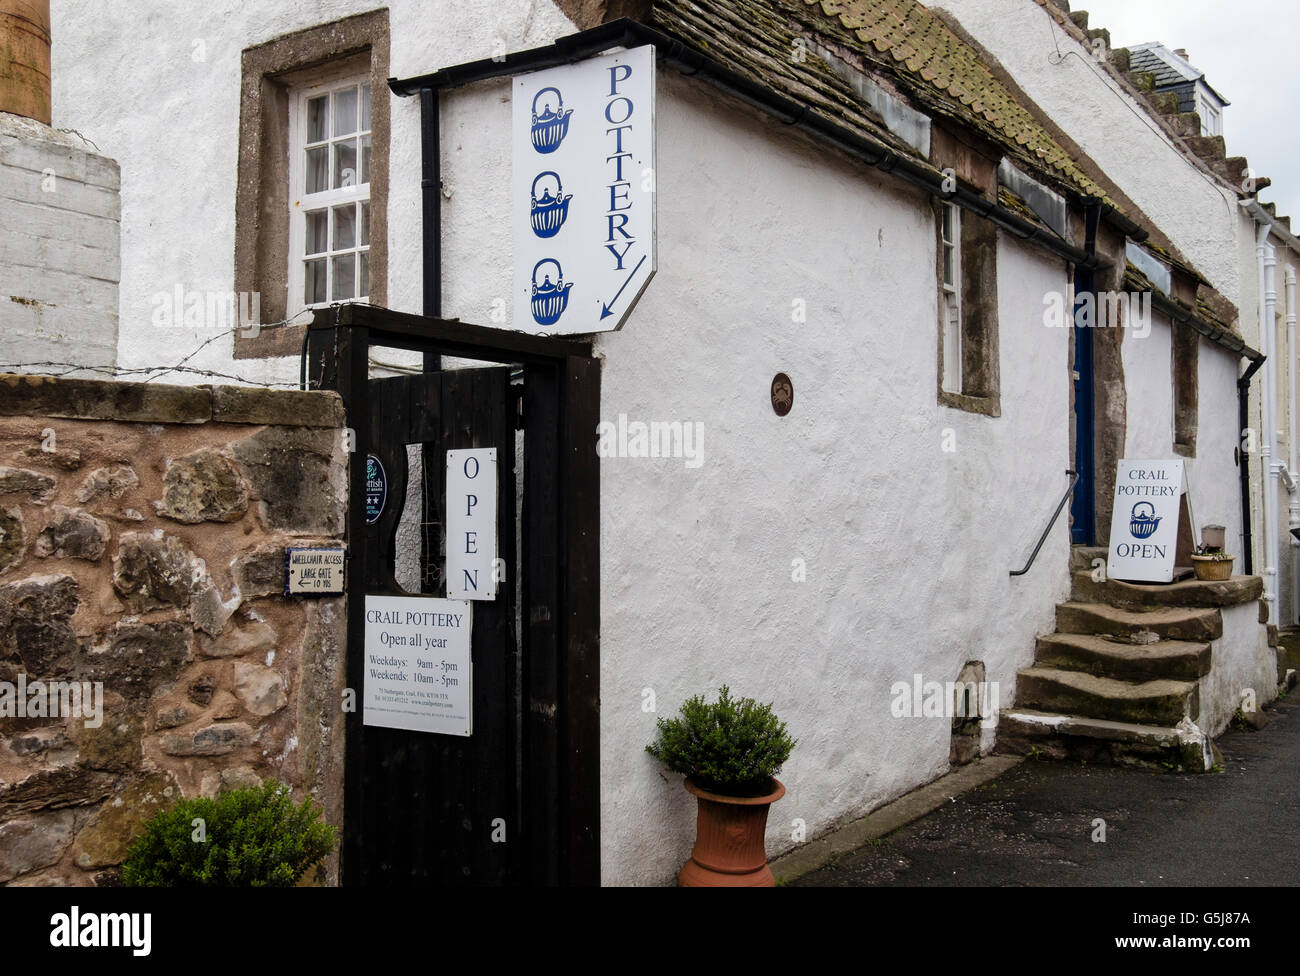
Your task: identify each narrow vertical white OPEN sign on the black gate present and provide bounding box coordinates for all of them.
[447,447,497,600]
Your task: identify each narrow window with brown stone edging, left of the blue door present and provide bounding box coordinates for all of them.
[937,201,1001,417]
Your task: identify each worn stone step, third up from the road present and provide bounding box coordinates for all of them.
[1034,634,1210,681]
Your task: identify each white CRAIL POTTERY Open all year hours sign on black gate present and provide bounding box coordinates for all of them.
[361,595,473,736]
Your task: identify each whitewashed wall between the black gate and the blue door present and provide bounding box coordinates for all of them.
[585,74,1069,884]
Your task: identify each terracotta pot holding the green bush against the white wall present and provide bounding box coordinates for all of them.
[677,778,785,888]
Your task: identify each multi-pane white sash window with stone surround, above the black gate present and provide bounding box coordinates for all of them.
[234,9,389,359]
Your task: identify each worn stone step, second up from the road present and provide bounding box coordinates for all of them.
[1015,665,1200,725]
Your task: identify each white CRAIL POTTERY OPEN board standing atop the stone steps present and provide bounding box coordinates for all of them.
[1106,457,1183,584]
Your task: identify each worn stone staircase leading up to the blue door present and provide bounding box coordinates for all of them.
[996,547,1260,772]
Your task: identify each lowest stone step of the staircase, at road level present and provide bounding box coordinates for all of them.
[993,708,1216,772]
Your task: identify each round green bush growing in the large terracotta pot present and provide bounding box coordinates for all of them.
[646,685,796,797]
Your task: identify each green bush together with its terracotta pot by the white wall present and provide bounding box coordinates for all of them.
[646,685,796,888]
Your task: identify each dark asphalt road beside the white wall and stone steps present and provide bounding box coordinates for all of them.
[793,689,1300,886]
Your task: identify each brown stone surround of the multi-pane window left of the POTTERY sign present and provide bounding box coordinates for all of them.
[234,8,389,359]
